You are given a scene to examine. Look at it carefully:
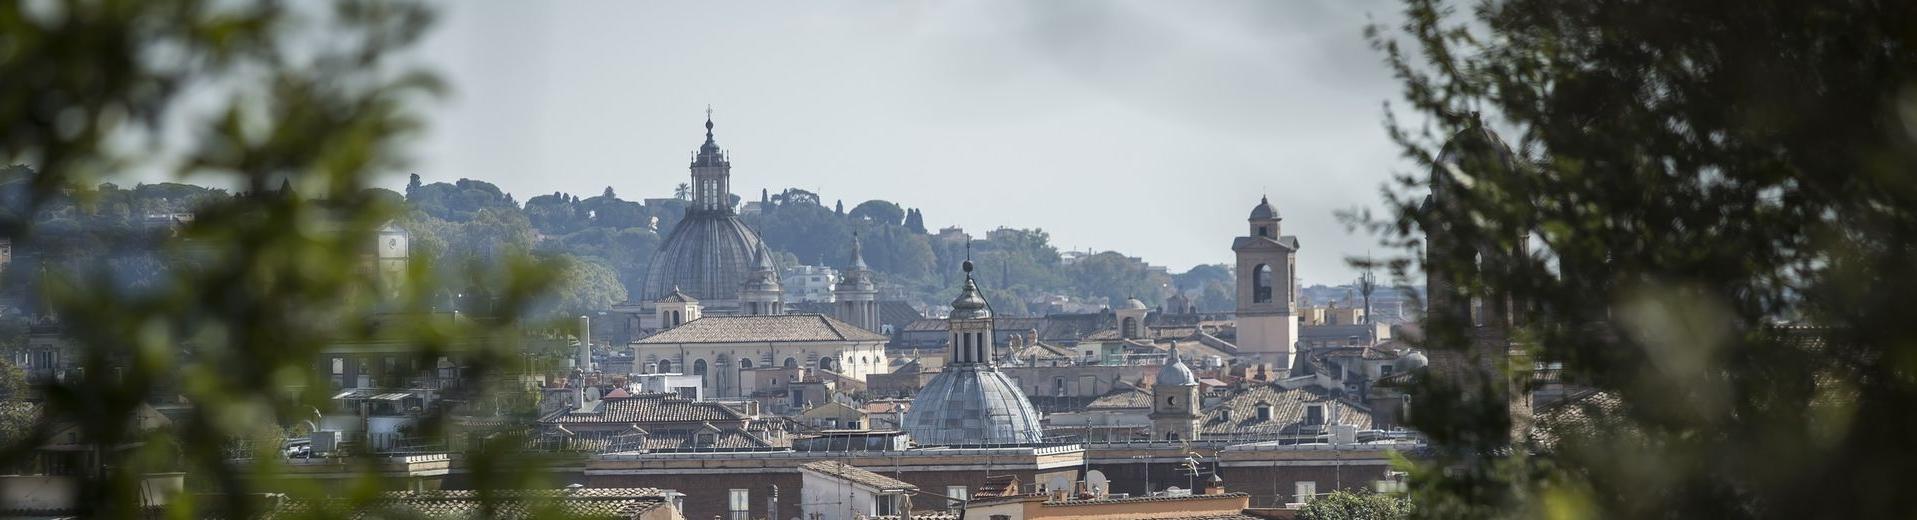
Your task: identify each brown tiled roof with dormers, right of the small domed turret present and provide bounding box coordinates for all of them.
[1200,384,1371,436]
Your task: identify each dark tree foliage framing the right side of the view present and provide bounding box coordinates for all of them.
[1351,0,1917,518]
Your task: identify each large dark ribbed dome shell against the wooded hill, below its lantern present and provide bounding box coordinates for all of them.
[640,211,773,307]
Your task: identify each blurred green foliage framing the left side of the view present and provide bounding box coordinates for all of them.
[0,0,550,518]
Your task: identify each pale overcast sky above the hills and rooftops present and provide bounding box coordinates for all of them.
[412,0,1403,284]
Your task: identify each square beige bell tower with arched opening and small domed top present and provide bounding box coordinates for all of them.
[1231,198,1298,366]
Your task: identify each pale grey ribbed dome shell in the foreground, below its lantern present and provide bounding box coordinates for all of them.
[905,365,1045,445]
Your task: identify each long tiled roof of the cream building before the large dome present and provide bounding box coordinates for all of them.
[633,315,889,345]
